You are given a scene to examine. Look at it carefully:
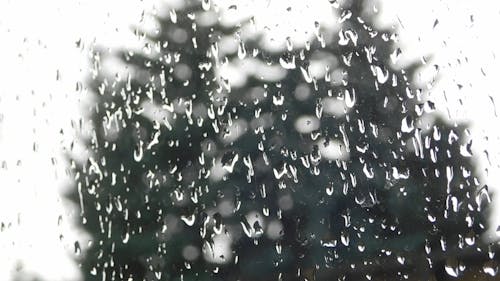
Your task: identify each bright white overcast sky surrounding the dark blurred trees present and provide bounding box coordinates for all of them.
[0,0,500,280]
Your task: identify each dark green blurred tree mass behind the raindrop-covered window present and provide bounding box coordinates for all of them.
[68,1,489,280]
